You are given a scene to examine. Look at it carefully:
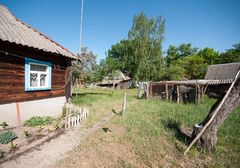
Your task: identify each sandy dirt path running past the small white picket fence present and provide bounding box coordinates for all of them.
[0,113,114,168]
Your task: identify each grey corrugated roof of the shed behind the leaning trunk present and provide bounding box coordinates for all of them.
[205,62,240,82]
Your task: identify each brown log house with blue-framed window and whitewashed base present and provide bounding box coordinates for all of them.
[0,5,78,125]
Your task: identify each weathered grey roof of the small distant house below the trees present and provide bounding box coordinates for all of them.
[101,71,131,85]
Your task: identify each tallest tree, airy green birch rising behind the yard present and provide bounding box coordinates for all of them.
[128,13,165,81]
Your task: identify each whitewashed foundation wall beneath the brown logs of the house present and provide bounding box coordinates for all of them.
[0,96,66,126]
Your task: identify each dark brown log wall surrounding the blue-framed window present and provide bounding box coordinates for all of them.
[0,41,71,104]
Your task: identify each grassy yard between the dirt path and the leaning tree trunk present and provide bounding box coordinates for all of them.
[56,89,240,167]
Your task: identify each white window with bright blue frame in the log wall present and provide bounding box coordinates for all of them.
[25,58,52,91]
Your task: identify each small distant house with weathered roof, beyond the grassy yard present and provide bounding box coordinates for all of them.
[98,71,131,89]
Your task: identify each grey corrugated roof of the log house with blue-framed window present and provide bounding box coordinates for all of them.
[0,5,79,59]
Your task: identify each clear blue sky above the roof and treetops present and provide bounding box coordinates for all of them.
[0,0,240,60]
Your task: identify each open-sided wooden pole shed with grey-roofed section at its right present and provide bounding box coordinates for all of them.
[146,62,240,103]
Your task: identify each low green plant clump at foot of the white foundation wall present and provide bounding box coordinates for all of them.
[24,116,54,127]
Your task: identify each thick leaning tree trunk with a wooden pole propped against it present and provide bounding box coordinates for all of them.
[192,78,240,152]
